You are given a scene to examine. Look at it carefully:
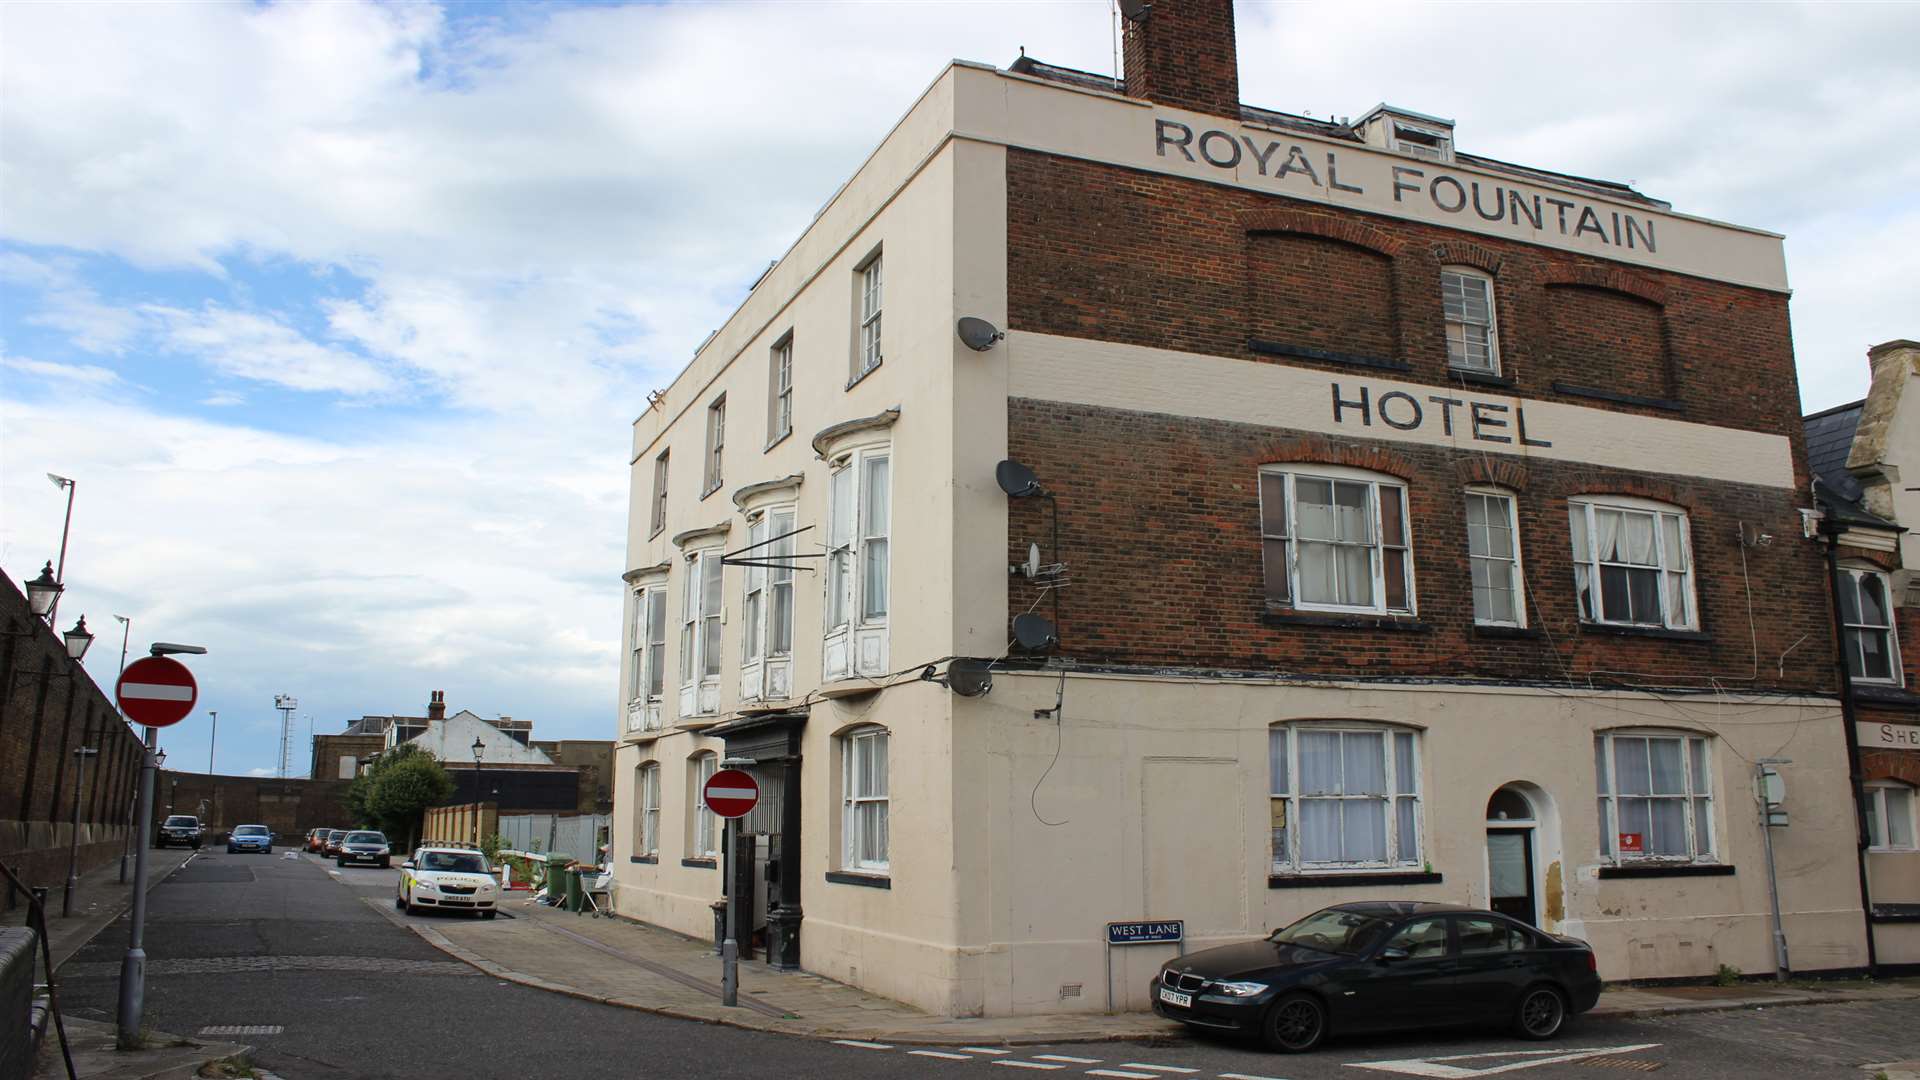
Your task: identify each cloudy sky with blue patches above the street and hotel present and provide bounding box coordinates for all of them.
[0,0,1920,773]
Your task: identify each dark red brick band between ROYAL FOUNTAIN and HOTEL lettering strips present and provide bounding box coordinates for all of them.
[1006,150,1807,478]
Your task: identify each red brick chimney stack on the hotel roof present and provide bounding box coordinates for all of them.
[1121,0,1240,119]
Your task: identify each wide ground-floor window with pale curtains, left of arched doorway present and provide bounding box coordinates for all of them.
[1267,723,1423,874]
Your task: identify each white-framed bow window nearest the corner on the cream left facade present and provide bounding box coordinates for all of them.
[822,444,895,678]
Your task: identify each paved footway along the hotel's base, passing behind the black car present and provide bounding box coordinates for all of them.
[367,864,1920,1045]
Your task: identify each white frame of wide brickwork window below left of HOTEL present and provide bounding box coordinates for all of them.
[1260,465,1419,615]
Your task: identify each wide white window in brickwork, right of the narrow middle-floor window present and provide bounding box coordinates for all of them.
[1567,498,1697,630]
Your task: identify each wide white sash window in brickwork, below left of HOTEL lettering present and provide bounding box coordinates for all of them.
[1260,465,1413,613]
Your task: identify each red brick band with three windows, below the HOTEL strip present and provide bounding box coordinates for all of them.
[1008,400,1837,690]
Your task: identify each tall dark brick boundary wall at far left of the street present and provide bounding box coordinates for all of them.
[0,573,140,886]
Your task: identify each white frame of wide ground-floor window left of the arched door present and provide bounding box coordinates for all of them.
[1267,721,1427,876]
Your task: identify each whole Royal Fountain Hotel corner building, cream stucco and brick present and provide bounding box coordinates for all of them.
[612,0,1864,1015]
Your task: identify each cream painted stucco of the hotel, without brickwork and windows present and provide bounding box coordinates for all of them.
[612,63,1862,1015]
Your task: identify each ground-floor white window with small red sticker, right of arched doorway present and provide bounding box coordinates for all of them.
[1594,732,1715,863]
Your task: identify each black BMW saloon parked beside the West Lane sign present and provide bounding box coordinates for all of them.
[1152,901,1599,1053]
